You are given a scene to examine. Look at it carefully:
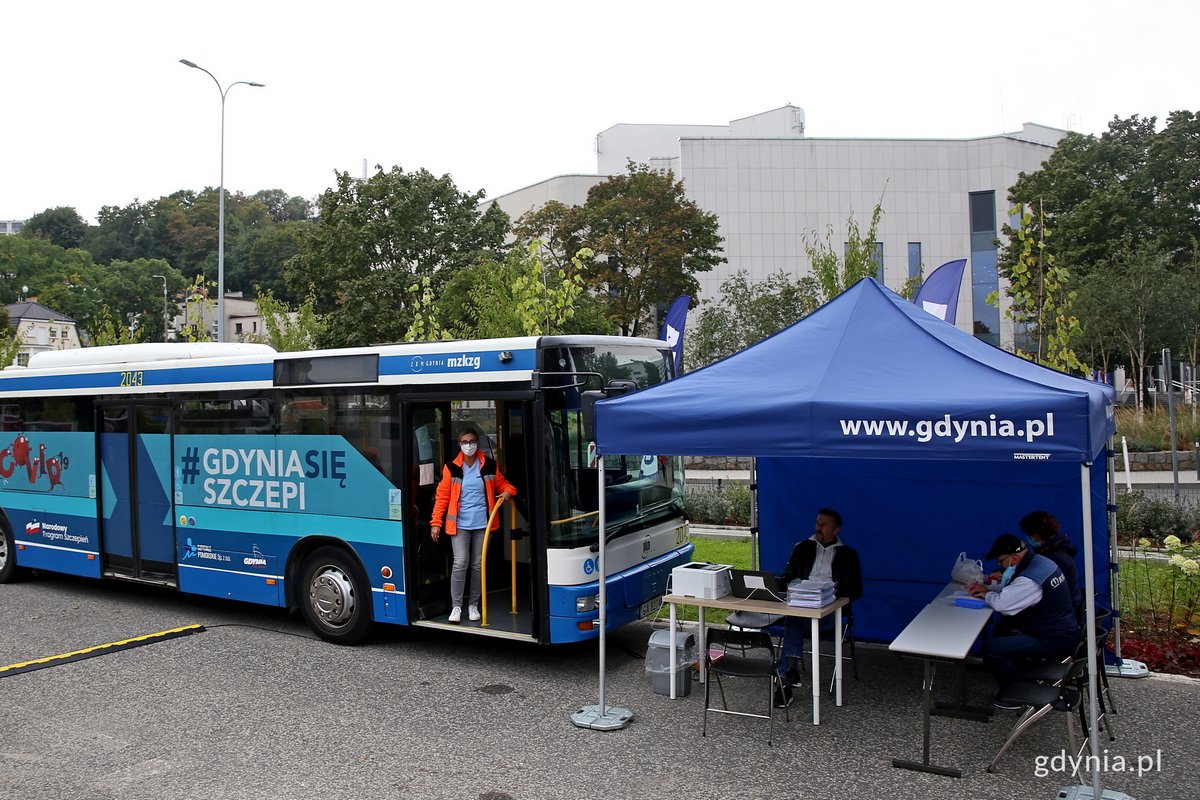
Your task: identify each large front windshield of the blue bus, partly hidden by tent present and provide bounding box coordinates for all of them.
[545,347,683,548]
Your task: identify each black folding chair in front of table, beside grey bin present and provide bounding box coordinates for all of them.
[701,628,791,747]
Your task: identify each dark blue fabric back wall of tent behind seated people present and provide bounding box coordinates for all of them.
[758,458,1109,642]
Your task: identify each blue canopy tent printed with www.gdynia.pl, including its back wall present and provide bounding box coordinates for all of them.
[595,278,1115,786]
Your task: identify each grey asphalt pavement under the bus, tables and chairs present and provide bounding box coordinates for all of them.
[0,577,1200,800]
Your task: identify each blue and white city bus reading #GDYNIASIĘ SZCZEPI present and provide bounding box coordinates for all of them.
[0,336,692,644]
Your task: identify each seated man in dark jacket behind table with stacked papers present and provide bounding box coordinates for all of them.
[775,509,863,708]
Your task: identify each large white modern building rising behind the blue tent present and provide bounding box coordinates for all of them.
[494,106,1066,344]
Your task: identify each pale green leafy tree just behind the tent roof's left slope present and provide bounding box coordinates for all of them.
[684,270,821,369]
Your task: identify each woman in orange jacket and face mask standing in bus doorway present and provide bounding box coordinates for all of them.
[430,428,517,622]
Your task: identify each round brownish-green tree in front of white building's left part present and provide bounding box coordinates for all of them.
[571,162,725,336]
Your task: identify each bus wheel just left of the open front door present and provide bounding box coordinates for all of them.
[300,547,371,644]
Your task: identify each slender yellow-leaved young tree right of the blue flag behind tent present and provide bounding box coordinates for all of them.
[988,207,1087,373]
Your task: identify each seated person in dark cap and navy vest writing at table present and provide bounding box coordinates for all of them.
[968,534,1079,709]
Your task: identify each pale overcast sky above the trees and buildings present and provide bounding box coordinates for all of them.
[0,0,1200,221]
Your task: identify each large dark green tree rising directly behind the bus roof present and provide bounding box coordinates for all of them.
[291,167,509,345]
